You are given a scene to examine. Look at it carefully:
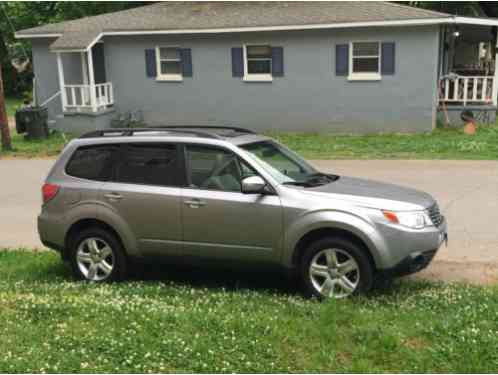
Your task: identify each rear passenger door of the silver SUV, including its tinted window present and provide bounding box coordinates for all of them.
[101,143,183,255]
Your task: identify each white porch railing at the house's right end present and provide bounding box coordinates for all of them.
[439,75,497,105]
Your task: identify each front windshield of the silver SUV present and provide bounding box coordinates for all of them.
[240,141,337,187]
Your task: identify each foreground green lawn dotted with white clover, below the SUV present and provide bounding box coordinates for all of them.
[0,251,498,373]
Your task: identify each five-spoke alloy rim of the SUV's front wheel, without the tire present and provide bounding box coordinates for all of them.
[309,249,360,298]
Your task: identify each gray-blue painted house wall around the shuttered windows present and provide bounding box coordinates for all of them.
[30,26,439,133]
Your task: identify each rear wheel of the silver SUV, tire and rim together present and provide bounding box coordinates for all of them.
[69,227,128,282]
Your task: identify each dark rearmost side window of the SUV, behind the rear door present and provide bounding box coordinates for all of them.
[66,146,119,181]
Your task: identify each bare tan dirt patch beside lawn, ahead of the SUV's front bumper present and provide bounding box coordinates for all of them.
[411,261,498,285]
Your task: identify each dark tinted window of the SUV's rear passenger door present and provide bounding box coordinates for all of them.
[116,144,180,186]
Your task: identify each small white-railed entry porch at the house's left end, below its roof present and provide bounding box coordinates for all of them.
[56,42,114,114]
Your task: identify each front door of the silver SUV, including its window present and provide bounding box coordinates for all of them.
[181,145,283,261]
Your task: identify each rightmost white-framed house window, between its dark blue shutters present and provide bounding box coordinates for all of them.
[349,42,381,80]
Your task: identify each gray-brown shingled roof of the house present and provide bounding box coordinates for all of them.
[17,1,451,49]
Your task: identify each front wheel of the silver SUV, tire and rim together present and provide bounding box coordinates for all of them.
[300,237,374,299]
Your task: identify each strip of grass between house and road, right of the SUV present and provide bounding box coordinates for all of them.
[267,126,498,160]
